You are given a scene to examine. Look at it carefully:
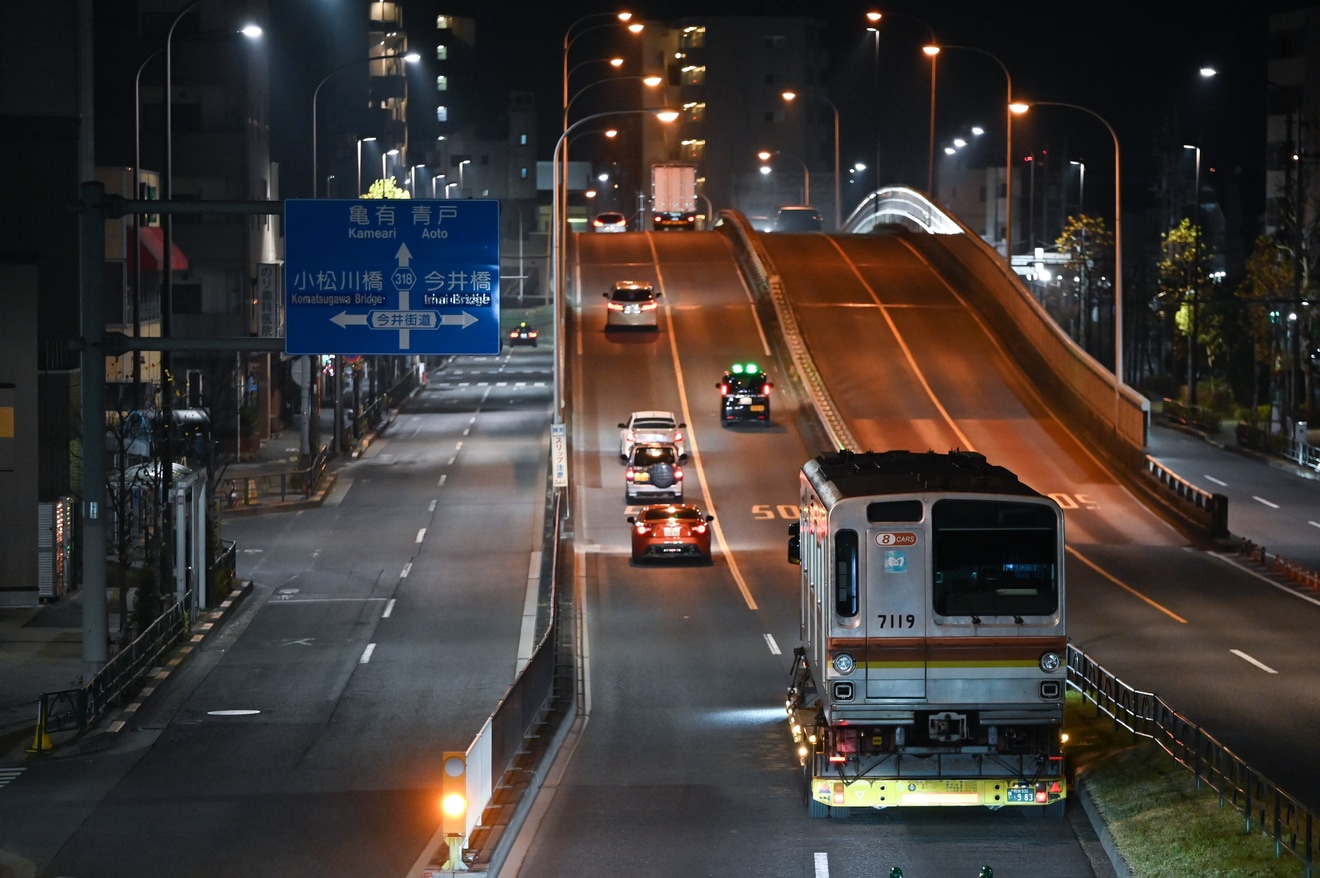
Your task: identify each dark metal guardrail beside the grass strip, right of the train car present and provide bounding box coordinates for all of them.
[1068,644,1320,878]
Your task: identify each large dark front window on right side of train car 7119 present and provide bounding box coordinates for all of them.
[931,499,1059,618]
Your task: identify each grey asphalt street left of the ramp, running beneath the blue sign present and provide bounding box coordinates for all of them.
[0,349,550,878]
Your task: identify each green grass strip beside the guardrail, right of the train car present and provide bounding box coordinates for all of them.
[1065,691,1304,878]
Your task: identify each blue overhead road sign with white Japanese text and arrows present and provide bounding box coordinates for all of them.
[284,198,503,355]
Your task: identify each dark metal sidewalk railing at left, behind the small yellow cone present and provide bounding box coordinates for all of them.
[30,591,193,753]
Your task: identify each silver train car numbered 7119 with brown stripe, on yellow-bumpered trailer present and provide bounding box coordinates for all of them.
[787,452,1068,817]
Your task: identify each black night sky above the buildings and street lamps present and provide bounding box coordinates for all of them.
[257,0,1303,236]
